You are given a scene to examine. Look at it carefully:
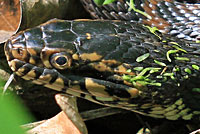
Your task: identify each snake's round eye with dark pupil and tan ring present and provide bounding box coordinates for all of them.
[50,52,72,69]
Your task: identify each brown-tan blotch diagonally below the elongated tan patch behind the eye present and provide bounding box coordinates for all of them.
[90,62,113,72]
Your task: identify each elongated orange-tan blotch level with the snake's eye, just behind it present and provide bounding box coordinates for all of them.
[80,53,102,61]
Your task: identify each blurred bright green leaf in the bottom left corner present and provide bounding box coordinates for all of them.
[0,91,32,134]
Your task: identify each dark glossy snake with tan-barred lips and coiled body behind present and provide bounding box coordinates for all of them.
[4,0,200,120]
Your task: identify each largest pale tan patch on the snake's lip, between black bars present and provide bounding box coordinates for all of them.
[85,78,110,97]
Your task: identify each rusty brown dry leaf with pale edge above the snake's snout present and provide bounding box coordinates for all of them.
[0,0,21,43]
